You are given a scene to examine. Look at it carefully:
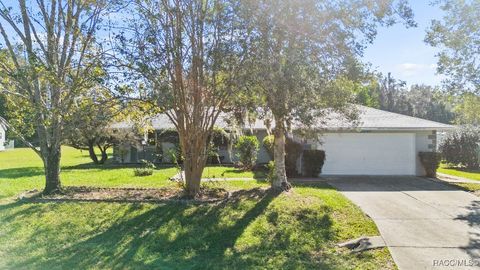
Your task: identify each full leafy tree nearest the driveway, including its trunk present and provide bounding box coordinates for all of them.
[242,0,414,189]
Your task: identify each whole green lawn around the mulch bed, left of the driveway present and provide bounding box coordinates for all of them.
[0,148,395,269]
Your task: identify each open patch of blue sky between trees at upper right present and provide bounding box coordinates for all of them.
[363,0,442,85]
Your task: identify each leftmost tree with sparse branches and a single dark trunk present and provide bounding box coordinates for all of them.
[0,0,107,194]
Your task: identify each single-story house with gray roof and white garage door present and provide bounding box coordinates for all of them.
[114,106,454,175]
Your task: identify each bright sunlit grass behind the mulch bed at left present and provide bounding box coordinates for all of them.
[0,147,177,199]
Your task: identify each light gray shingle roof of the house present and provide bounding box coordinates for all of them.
[112,105,455,131]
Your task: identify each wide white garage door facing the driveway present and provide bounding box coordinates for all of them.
[321,133,416,175]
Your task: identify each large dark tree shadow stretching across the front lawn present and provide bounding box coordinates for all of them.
[0,189,276,269]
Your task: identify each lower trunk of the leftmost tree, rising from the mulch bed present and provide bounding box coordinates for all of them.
[43,147,62,194]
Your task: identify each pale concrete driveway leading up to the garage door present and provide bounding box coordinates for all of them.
[327,176,480,269]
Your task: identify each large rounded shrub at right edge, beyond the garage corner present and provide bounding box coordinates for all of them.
[440,127,480,169]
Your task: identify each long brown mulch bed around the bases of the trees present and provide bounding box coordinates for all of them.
[19,186,230,203]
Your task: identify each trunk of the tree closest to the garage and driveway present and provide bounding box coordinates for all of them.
[272,118,291,191]
